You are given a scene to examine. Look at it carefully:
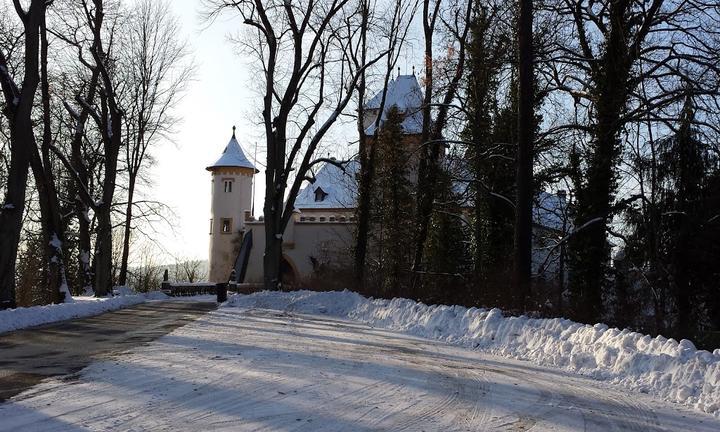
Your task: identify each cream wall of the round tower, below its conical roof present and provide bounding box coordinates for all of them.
[208,167,254,282]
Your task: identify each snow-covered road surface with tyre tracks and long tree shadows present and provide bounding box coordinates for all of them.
[0,308,720,432]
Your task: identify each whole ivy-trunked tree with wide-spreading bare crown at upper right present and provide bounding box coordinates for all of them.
[543,0,718,321]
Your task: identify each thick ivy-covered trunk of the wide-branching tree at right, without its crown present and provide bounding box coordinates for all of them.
[568,2,632,322]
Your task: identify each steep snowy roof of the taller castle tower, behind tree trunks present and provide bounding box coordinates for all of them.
[365,75,423,135]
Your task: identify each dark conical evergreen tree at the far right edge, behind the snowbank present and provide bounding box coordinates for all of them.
[615,98,720,338]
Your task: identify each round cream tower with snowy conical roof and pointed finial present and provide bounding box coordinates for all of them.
[206,126,258,282]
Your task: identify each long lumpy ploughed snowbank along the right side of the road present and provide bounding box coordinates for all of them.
[227,291,720,415]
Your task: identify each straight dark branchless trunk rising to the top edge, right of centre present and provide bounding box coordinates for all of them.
[515,0,535,310]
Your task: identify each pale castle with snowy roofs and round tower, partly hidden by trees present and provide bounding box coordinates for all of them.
[207,75,566,284]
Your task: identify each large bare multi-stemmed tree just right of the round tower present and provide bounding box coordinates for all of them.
[205,0,387,289]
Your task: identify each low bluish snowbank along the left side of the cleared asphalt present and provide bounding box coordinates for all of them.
[0,287,167,333]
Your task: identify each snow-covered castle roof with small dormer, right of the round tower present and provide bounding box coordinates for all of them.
[295,160,360,211]
